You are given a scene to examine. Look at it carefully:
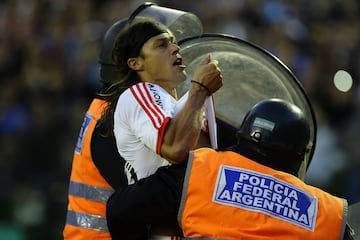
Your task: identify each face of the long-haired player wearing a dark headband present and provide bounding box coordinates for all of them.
[138,33,186,91]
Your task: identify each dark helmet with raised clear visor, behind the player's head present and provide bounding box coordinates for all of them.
[99,2,203,84]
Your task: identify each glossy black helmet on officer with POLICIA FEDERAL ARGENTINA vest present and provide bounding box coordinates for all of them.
[237,98,310,176]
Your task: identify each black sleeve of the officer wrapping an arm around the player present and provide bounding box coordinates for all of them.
[106,165,186,240]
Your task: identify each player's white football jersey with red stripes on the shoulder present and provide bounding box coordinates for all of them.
[114,82,184,183]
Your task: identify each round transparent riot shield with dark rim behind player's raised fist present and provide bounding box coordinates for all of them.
[177,34,316,168]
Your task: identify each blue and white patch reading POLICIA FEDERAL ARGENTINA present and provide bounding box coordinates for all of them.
[213,165,318,231]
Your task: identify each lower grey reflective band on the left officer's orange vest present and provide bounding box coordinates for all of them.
[66,210,109,232]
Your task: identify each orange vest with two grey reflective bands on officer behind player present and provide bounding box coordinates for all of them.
[63,99,114,240]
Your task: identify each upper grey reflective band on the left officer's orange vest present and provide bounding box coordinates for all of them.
[69,181,114,202]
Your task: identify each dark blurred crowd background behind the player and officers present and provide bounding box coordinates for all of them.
[0,0,360,240]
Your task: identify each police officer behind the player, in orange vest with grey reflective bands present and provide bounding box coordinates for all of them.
[63,19,127,239]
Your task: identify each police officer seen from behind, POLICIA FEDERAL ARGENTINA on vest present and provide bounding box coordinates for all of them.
[107,99,353,239]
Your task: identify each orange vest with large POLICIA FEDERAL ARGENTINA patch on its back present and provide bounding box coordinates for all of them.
[178,148,347,240]
